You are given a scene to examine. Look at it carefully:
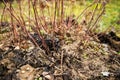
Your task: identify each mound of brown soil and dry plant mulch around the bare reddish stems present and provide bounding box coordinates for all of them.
[0,20,120,80]
